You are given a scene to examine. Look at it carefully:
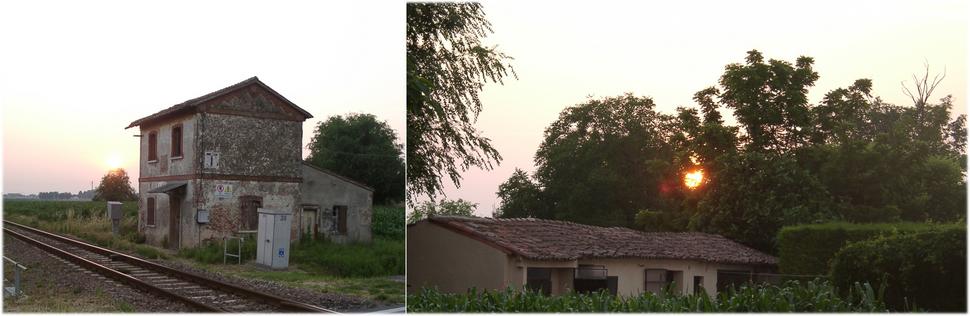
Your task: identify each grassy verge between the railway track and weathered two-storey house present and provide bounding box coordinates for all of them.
[3,200,404,304]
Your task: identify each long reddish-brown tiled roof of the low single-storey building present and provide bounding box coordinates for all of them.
[428,216,778,265]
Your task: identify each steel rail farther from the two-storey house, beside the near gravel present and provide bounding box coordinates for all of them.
[3,227,228,313]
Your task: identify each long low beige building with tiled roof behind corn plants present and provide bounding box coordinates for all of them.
[407,216,777,296]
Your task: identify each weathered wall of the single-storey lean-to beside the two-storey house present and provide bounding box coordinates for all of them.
[301,164,374,243]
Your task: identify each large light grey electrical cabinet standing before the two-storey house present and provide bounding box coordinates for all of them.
[256,208,293,269]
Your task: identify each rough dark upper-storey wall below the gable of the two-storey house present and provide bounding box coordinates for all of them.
[198,113,303,178]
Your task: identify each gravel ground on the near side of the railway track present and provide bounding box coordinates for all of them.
[3,235,196,313]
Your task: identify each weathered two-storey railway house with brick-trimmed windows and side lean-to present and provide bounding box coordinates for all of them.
[126,77,373,249]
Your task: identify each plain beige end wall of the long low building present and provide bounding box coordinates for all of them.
[407,221,508,293]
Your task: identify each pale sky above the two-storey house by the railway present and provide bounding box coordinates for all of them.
[0,0,405,193]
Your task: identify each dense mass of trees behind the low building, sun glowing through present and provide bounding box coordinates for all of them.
[496,50,967,252]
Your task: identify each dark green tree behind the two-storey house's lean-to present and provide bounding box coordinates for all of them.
[306,114,404,203]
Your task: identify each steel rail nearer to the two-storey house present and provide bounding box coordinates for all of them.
[3,220,337,313]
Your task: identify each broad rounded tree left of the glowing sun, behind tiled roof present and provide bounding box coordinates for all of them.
[532,94,676,226]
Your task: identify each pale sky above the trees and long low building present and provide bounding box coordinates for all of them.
[434,1,968,216]
